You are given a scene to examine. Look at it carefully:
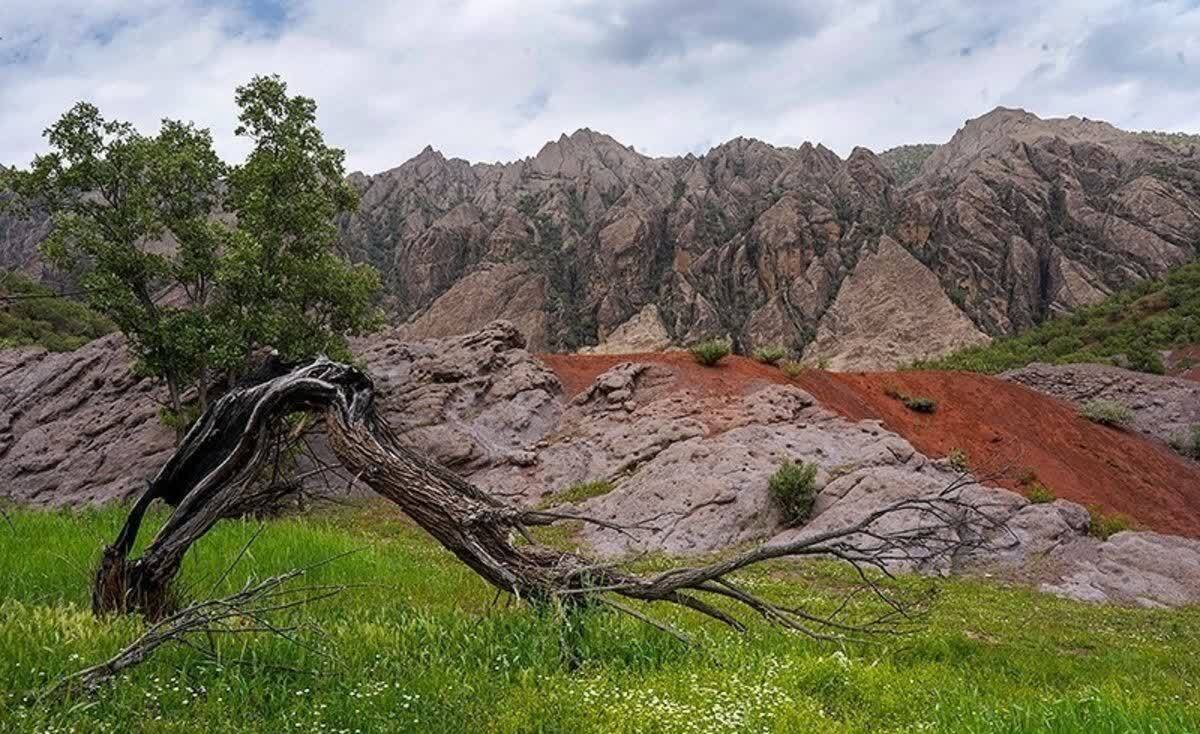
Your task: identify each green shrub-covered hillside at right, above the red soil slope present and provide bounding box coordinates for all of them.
[912,263,1200,374]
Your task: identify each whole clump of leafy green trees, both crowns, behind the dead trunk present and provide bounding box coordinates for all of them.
[0,77,379,429]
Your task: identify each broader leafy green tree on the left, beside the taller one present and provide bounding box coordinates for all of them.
[6,102,224,426]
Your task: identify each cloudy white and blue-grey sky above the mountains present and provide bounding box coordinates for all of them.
[0,0,1200,173]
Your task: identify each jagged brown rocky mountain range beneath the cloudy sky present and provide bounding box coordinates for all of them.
[9,108,1200,368]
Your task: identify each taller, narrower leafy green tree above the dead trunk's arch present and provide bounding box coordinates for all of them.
[220,77,379,365]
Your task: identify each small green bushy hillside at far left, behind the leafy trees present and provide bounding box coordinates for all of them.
[0,271,115,351]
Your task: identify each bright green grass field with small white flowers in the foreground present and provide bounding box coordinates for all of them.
[0,506,1200,734]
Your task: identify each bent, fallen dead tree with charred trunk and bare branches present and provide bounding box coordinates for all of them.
[92,359,1003,637]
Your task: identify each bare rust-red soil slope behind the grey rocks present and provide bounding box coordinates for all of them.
[542,353,1200,537]
